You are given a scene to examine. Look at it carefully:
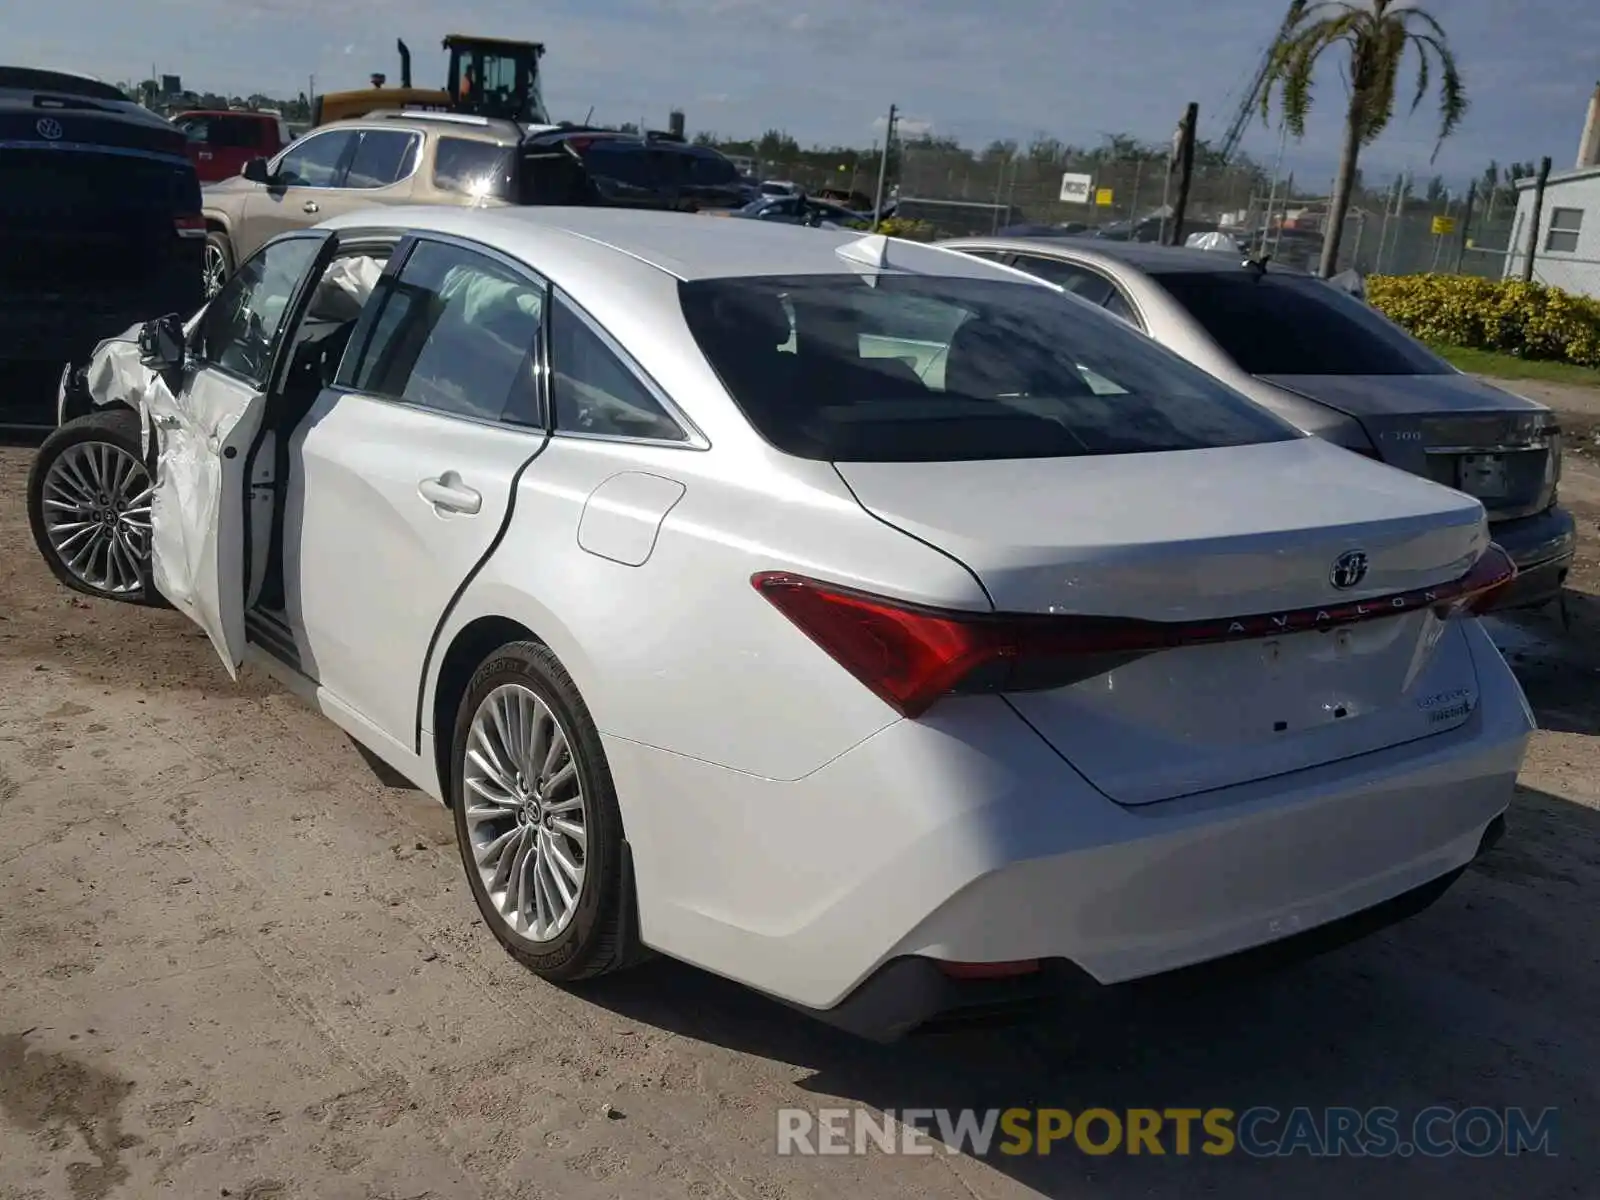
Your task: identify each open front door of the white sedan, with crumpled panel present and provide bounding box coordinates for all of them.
[144,230,338,678]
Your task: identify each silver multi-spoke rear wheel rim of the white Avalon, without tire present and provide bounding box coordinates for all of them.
[461,683,589,942]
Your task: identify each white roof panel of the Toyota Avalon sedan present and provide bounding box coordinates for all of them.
[323,205,1018,282]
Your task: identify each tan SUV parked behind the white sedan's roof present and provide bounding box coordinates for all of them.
[202,112,523,298]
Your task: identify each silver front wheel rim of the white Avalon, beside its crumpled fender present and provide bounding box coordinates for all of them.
[43,442,155,595]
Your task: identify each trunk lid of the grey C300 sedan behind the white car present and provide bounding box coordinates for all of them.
[1259,373,1560,522]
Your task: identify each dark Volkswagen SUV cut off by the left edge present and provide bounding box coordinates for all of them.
[0,66,205,424]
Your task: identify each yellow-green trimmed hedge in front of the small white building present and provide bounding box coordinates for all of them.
[1366,275,1600,366]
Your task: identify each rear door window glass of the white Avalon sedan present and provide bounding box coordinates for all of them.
[341,242,544,424]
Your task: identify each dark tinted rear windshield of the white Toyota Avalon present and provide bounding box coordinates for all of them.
[678,274,1299,462]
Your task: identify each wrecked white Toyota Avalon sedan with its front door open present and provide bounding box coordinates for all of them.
[32,208,1533,1037]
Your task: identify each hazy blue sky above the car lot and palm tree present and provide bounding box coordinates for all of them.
[15,0,1600,178]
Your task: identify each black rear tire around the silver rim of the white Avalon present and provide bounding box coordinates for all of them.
[450,642,643,982]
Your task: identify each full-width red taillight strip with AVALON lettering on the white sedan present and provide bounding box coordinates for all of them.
[750,544,1517,717]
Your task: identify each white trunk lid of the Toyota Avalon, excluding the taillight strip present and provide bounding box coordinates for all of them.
[837,438,1488,805]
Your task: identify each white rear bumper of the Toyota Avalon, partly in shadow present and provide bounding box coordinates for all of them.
[606,622,1533,1037]
